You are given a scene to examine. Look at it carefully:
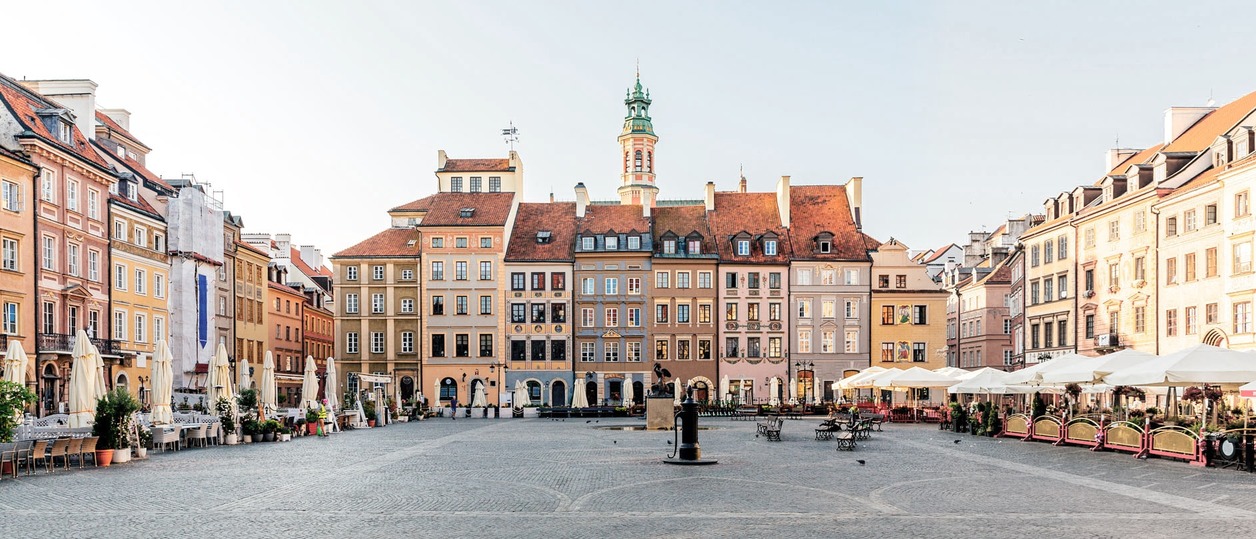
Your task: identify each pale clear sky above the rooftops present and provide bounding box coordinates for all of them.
[0,0,1256,254]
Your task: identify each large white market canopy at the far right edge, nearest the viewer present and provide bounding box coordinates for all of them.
[1104,344,1256,387]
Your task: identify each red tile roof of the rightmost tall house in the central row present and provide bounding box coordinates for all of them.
[783,185,880,260]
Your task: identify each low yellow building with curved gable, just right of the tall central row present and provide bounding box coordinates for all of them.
[869,239,950,376]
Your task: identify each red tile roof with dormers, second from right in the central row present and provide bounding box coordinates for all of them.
[707,192,793,264]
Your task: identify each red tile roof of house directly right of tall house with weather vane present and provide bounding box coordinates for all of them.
[506,202,575,261]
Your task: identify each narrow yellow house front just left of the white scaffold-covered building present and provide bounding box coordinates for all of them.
[109,177,170,400]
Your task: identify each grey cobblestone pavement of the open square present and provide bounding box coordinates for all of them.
[0,418,1256,539]
